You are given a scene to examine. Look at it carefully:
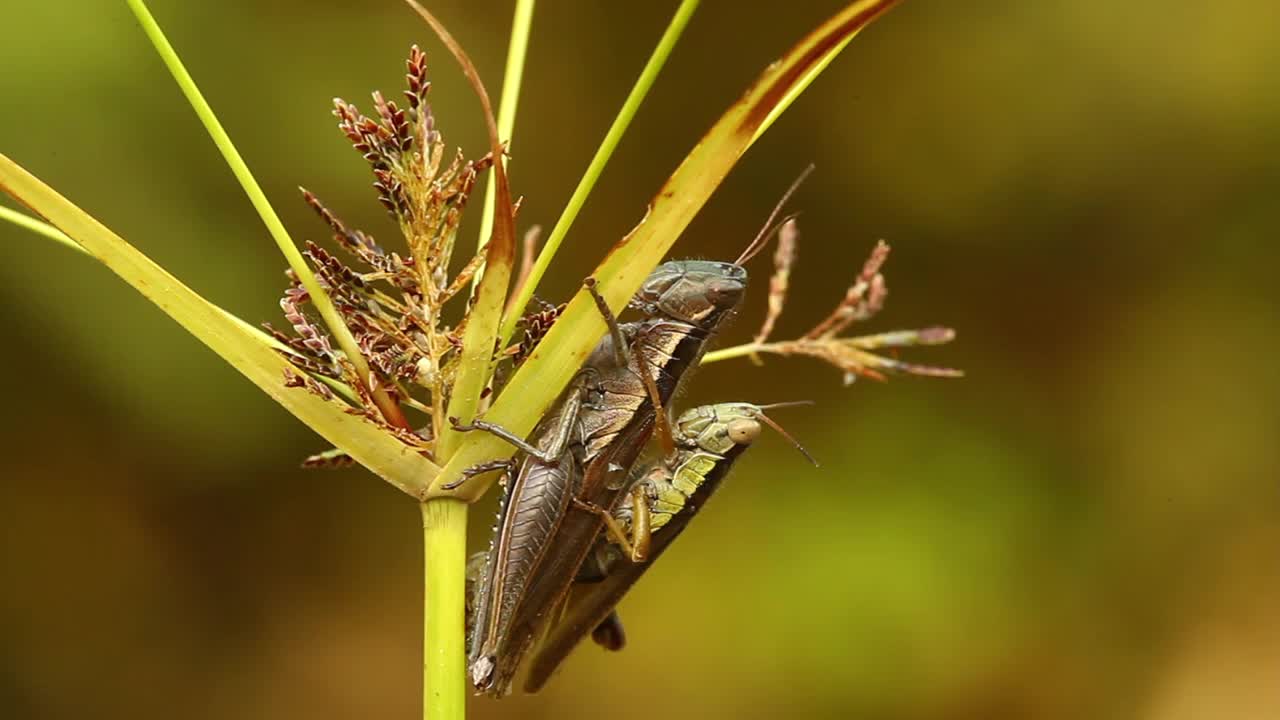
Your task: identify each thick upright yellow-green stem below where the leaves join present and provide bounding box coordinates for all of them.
[421,497,467,720]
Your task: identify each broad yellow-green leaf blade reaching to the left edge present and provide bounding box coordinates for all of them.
[0,155,439,496]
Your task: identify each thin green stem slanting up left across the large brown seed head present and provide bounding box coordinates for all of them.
[125,0,408,428]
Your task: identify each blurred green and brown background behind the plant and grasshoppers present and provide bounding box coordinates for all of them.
[0,0,1280,720]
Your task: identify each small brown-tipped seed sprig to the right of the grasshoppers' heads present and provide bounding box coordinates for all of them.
[708,225,964,384]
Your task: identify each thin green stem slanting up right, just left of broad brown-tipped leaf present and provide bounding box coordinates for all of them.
[498,0,698,347]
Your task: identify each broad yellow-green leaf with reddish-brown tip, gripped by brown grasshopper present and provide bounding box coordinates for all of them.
[433,0,899,497]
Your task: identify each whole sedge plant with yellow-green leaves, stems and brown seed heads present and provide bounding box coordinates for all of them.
[0,0,955,720]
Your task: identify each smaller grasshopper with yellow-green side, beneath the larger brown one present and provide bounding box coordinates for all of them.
[525,402,817,692]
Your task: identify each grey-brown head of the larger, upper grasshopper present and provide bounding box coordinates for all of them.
[632,260,746,329]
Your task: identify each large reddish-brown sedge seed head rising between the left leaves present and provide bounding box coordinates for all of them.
[271,46,509,466]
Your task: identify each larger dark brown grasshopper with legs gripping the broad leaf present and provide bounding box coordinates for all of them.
[460,170,803,697]
